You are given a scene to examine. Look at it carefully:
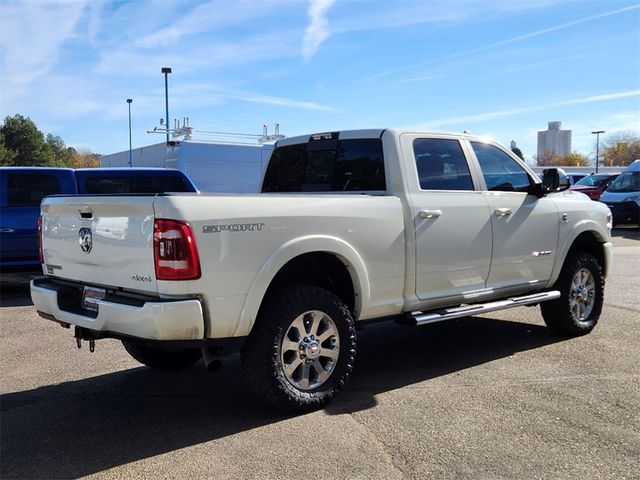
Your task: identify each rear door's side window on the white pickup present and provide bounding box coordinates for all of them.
[413,138,473,190]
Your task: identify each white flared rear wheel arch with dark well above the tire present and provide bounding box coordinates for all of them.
[235,236,371,336]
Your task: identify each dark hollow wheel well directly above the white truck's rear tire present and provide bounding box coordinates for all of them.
[265,252,356,315]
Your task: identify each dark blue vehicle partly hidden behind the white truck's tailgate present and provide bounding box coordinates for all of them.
[0,167,197,282]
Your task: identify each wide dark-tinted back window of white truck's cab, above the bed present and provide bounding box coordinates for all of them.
[262,138,386,192]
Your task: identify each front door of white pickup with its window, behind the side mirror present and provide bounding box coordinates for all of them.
[470,141,558,293]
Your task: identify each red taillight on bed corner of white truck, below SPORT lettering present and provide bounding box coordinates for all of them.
[153,219,200,280]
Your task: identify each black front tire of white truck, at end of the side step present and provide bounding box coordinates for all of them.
[540,252,604,337]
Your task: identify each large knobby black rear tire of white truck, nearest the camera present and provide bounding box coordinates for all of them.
[241,286,356,412]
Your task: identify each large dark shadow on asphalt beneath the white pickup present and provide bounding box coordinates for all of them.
[0,318,562,478]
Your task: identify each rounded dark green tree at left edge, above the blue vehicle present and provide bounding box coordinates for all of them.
[0,114,54,166]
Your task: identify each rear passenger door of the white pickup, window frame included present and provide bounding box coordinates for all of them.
[401,134,491,305]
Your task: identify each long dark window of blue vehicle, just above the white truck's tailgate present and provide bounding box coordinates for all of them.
[84,175,193,194]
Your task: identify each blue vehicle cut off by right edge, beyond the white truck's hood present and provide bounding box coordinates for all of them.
[600,159,640,226]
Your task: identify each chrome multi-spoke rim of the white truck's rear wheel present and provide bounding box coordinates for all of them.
[280,310,340,390]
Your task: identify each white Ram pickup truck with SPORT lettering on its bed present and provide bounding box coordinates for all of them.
[31,129,612,411]
